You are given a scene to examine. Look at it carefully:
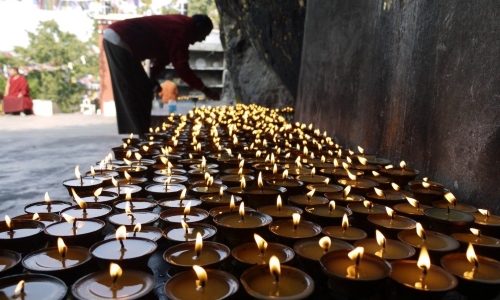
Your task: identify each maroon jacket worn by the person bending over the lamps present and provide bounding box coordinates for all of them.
[109,15,204,90]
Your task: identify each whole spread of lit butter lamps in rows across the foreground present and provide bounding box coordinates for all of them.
[0,105,500,299]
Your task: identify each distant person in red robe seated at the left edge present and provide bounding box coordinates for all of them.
[3,67,33,115]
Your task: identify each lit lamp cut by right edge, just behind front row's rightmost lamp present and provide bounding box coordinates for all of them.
[451,228,500,259]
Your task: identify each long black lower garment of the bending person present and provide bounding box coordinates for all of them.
[103,40,153,134]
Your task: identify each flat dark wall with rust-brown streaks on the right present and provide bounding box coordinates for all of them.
[296,0,500,212]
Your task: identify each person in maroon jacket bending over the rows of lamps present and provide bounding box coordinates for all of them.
[103,15,220,134]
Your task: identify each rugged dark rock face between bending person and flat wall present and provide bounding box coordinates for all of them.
[216,0,305,107]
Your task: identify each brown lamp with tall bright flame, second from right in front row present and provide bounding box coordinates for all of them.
[391,246,458,297]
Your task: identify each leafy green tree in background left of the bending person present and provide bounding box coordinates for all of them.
[15,21,98,112]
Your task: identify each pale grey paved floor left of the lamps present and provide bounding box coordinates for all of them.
[0,102,223,219]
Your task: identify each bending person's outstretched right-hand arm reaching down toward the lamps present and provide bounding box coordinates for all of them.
[172,47,220,100]
